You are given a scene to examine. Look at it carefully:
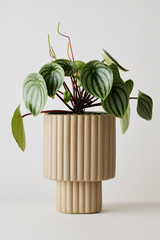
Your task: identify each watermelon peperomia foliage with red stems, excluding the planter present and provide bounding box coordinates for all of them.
[11,23,153,151]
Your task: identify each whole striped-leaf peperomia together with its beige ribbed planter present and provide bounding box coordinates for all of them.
[11,24,153,213]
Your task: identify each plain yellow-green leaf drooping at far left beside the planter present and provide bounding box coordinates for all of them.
[11,105,26,152]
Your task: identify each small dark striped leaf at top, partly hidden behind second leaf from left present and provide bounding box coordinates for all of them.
[54,59,77,76]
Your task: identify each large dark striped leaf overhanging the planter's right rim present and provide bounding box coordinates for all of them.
[101,82,129,118]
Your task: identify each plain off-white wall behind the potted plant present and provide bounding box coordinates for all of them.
[0,0,160,239]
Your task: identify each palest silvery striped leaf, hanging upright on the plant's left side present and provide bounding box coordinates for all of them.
[23,73,47,116]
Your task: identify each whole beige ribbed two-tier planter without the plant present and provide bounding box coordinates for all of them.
[43,113,116,213]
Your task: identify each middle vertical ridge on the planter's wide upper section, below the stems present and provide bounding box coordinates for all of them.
[77,115,84,181]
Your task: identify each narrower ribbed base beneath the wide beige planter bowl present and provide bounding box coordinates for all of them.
[56,181,102,213]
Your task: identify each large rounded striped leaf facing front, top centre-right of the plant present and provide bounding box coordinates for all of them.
[80,60,113,99]
